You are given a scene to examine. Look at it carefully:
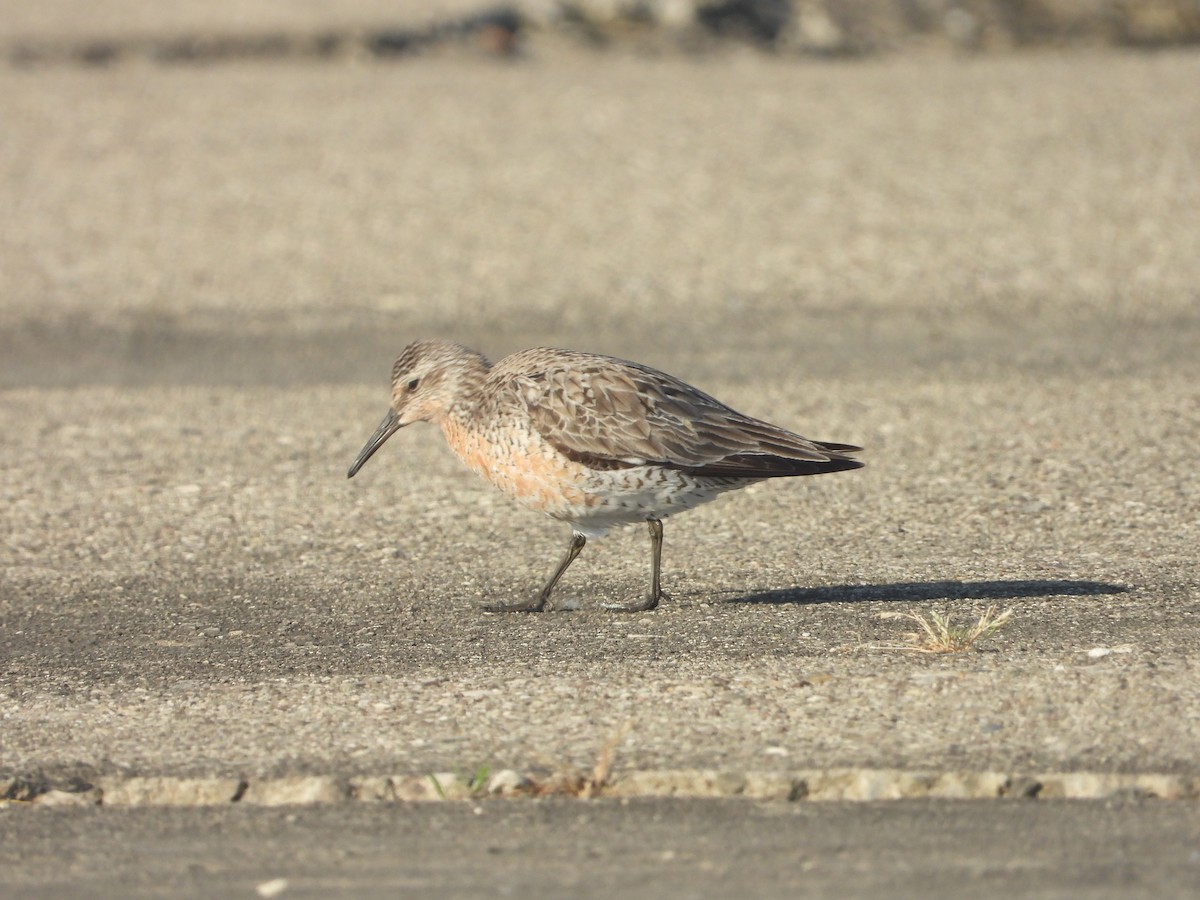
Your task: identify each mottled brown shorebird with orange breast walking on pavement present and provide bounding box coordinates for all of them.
[347,341,863,612]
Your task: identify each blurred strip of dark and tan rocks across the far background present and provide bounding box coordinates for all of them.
[0,0,1200,66]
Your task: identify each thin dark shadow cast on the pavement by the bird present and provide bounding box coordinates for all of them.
[728,578,1130,604]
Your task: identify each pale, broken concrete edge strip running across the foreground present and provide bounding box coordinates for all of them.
[0,768,1200,808]
